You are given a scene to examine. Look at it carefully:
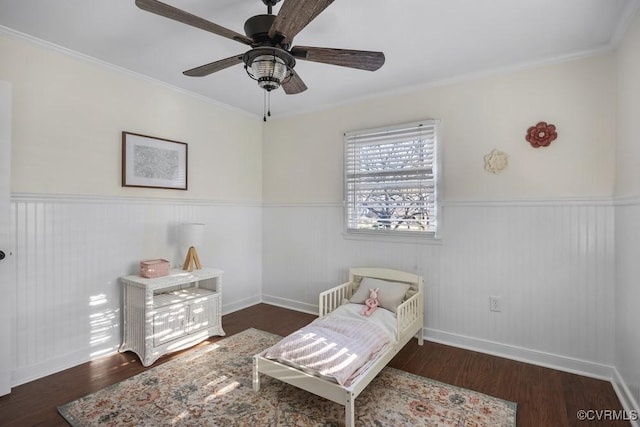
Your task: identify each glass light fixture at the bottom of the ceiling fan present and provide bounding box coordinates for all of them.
[243,47,296,92]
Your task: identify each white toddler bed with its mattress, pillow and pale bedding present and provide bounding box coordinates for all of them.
[253,268,424,427]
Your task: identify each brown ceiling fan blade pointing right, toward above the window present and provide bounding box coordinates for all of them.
[291,46,384,71]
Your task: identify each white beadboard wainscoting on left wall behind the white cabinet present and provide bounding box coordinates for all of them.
[11,193,262,386]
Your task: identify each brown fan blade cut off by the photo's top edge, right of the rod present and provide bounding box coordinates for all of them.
[269,0,333,44]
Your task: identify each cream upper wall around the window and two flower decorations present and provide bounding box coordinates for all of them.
[263,55,615,203]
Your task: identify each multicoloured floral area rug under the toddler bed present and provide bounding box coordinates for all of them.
[58,329,516,427]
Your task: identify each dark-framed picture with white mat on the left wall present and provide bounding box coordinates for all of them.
[122,132,187,190]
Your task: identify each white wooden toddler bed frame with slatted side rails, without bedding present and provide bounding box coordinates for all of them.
[253,268,424,427]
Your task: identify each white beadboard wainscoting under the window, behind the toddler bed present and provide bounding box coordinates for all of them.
[262,199,615,379]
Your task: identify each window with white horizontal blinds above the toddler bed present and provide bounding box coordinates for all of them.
[345,120,438,237]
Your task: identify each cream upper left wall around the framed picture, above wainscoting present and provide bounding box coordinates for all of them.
[0,35,262,202]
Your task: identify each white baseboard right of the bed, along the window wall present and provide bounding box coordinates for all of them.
[423,328,613,381]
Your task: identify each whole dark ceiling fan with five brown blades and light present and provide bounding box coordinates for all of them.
[136,0,385,99]
